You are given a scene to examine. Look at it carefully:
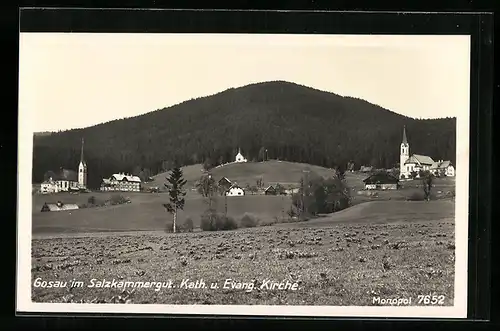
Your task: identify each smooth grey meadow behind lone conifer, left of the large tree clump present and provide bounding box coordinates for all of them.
[32,192,291,234]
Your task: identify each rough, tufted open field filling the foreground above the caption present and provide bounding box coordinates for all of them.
[32,213,455,305]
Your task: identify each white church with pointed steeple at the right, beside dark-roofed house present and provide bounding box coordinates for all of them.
[399,127,455,179]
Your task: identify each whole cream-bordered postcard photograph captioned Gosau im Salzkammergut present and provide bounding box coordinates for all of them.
[18,33,470,317]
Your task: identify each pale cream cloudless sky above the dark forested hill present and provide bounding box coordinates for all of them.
[19,33,470,132]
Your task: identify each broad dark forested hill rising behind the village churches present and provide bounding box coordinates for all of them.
[33,81,456,187]
